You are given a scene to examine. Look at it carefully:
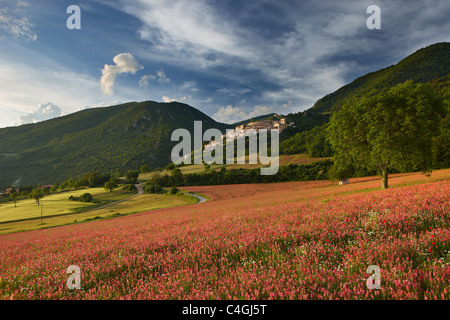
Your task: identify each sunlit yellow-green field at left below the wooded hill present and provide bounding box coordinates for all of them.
[0,188,197,234]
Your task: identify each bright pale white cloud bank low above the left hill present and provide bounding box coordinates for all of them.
[0,48,141,127]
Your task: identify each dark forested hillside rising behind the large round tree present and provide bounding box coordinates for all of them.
[280,43,450,167]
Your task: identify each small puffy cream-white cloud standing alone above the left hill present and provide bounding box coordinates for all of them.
[100,53,143,95]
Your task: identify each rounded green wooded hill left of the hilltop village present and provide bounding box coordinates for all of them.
[0,101,230,187]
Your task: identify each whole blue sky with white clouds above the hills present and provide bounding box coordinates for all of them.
[0,0,450,127]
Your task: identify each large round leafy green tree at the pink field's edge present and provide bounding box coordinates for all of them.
[327,80,445,189]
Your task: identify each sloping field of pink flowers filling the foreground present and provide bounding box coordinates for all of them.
[0,171,450,299]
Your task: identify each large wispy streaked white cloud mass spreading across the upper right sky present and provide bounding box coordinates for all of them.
[124,0,450,116]
